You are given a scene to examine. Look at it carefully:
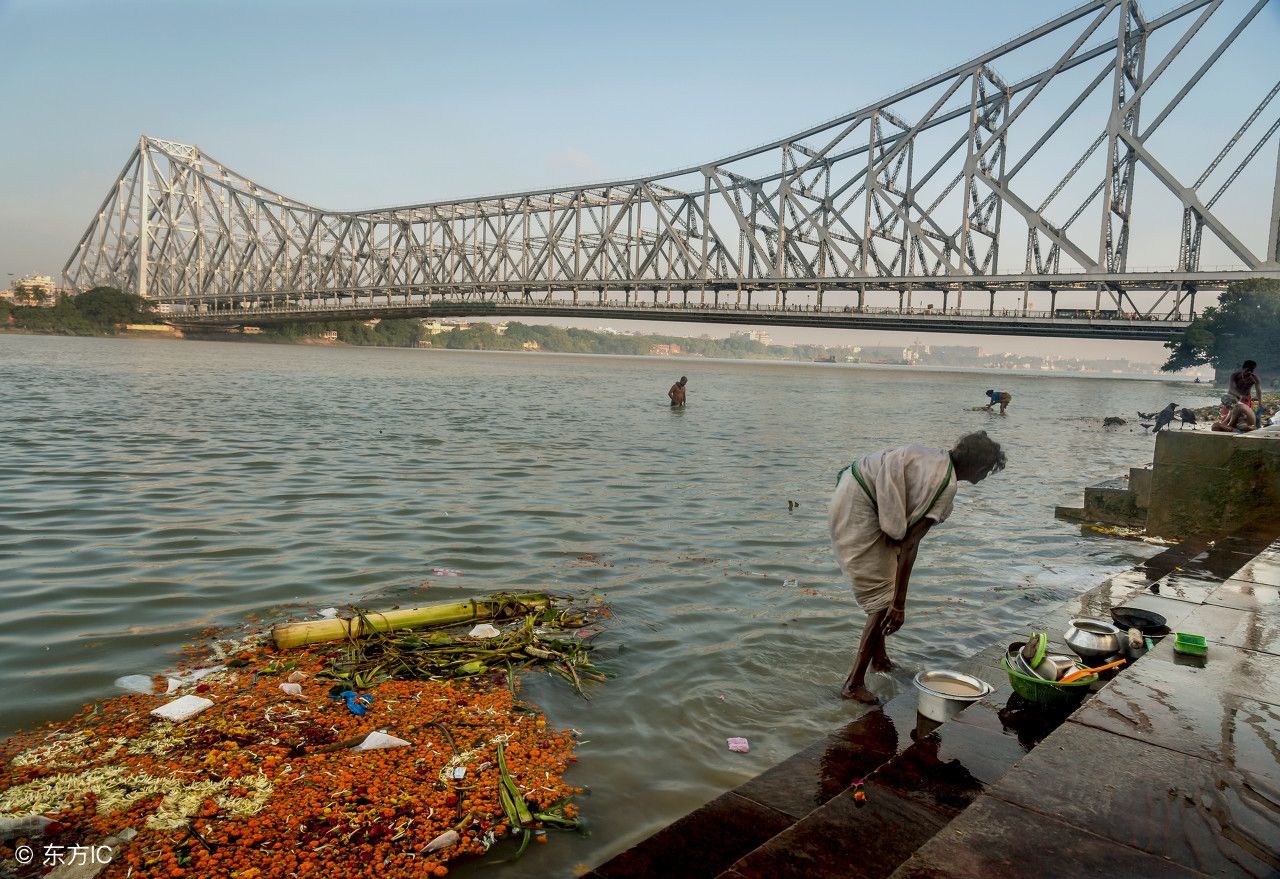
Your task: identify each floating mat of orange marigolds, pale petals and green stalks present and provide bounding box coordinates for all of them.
[0,596,604,879]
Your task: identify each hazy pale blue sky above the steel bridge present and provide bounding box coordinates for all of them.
[0,0,1280,360]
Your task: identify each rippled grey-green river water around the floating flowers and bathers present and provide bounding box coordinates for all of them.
[0,335,1212,876]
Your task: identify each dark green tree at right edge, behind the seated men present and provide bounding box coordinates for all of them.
[1160,278,1280,377]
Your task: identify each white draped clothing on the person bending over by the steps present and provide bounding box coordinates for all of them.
[829,445,956,614]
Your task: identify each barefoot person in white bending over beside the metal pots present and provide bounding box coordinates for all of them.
[829,431,1005,704]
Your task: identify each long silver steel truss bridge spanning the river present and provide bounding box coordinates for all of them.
[63,0,1280,339]
